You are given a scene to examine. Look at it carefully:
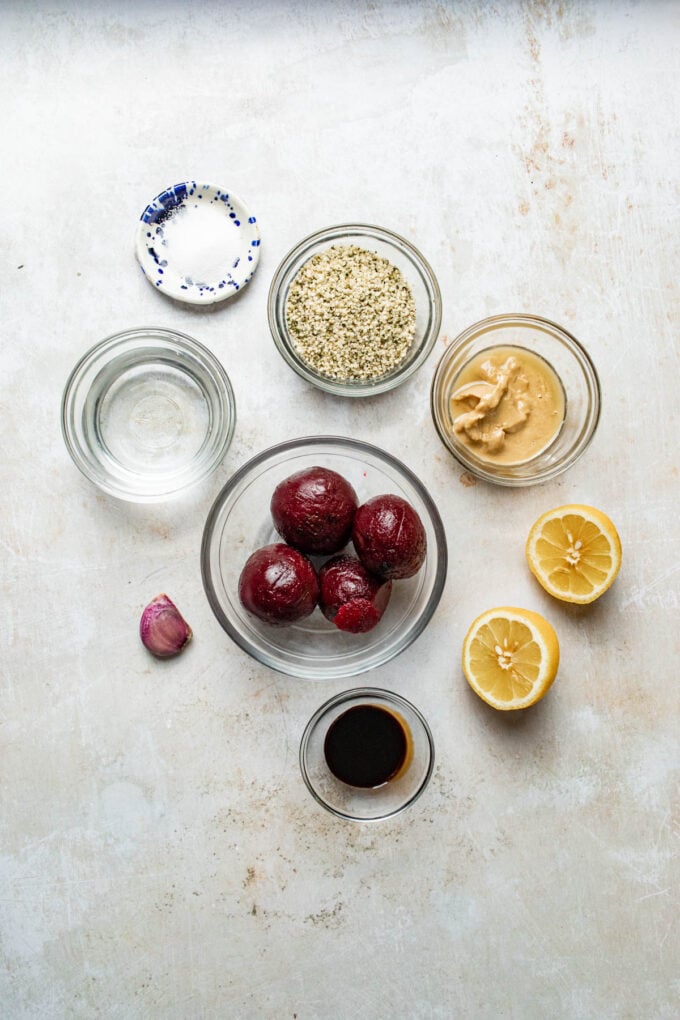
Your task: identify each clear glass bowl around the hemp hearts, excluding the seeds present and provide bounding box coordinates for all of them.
[268,223,441,397]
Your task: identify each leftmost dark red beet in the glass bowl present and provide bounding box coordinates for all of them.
[239,543,319,626]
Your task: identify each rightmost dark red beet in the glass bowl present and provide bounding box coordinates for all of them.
[352,495,427,580]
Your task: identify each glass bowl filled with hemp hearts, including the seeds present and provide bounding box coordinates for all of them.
[268,223,441,397]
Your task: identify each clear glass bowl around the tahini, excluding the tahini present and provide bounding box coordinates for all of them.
[431,315,600,486]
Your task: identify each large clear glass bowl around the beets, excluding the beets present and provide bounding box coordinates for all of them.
[201,437,447,679]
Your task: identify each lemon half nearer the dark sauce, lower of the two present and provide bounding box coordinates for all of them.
[463,606,560,711]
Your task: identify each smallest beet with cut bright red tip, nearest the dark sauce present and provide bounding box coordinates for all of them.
[319,556,391,633]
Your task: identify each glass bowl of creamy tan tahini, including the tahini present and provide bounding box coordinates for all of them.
[430,314,600,486]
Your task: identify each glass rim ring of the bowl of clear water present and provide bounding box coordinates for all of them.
[60,326,237,503]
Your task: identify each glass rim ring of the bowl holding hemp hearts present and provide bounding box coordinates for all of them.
[267,222,442,398]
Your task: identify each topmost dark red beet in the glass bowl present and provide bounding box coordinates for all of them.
[271,467,359,555]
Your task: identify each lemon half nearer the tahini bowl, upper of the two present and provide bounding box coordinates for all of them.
[526,503,621,605]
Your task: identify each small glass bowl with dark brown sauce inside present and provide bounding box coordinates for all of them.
[300,687,434,821]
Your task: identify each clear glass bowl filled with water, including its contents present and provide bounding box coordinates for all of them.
[61,328,236,503]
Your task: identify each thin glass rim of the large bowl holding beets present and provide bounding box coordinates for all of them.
[201,436,449,682]
